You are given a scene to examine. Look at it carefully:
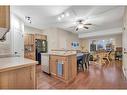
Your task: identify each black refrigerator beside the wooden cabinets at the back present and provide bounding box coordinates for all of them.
[36,39,47,64]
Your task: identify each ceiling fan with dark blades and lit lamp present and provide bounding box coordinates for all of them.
[70,20,92,32]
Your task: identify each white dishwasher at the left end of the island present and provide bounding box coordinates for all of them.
[41,53,50,74]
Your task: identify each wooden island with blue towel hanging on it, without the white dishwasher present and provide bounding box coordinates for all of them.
[50,52,77,83]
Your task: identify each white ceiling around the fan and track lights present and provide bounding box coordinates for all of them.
[12,6,124,34]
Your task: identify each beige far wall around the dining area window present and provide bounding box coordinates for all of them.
[80,34,122,51]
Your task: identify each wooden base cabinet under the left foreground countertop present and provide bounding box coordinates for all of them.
[0,65,36,89]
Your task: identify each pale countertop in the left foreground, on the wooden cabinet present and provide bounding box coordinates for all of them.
[0,57,37,72]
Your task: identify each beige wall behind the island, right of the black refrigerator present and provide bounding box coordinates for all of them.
[43,28,79,52]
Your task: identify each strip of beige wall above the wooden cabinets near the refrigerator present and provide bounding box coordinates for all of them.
[24,25,43,34]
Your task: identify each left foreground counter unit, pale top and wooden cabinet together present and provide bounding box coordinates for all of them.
[0,57,36,89]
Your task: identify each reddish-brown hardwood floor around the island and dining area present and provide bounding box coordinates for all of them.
[37,61,127,89]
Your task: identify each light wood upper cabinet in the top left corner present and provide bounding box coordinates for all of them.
[0,5,10,28]
